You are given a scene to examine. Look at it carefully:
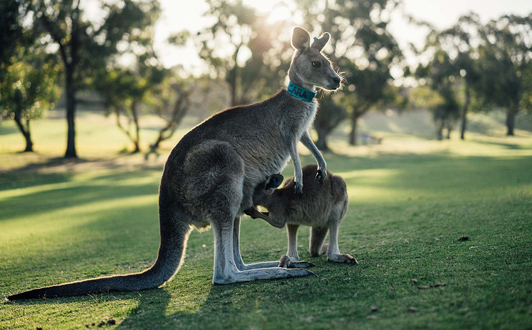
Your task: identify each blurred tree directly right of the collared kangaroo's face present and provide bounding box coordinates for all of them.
[297,0,402,145]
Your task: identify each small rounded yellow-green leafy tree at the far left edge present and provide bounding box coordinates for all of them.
[0,47,59,152]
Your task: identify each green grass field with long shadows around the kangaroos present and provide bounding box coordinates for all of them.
[0,111,532,329]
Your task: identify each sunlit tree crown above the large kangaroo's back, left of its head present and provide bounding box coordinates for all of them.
[172,0,292,106]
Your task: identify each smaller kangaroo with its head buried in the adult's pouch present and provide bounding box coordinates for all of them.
[246,165,358,268]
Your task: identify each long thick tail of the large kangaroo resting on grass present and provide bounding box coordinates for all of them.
[7,210,191,300]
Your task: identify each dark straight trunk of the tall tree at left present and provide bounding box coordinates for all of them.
[65,64,78,158]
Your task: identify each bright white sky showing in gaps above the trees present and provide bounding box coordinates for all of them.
[155,0,532,71]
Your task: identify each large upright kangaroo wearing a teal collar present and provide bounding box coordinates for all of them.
[8,28,341,300]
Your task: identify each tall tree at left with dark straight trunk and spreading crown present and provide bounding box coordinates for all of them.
[30,0,158,158]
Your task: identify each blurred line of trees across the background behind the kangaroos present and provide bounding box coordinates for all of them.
[0,0,532,158]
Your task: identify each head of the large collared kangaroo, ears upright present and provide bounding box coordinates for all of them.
[288,27,342,90]
